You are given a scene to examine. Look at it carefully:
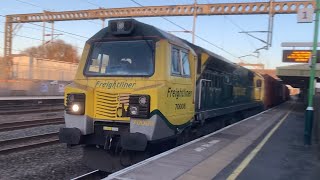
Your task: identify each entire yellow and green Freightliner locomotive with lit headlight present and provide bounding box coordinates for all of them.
[59,19,263,171]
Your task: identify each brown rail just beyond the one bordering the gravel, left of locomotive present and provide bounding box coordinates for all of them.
[0,117,64,132]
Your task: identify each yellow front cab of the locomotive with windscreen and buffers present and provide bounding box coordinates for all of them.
[59,19,195,155]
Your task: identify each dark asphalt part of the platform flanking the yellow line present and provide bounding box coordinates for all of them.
[213,103,320,180]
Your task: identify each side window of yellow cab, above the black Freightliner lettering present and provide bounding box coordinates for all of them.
[171,47,190,77]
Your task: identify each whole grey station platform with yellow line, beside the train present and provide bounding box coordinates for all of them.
[105,101,320,180]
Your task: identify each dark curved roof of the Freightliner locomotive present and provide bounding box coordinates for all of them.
[87,19,251,71]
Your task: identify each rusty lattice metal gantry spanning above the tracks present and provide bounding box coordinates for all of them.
[4,0,315,58]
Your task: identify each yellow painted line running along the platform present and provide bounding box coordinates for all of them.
[227,110,291,180]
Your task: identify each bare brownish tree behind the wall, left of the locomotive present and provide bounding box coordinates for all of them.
[24,40,79,62]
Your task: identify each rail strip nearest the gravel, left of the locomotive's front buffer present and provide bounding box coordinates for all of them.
[0,132,59,154]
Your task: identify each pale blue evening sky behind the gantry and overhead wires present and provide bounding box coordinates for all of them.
[0,0,314,68]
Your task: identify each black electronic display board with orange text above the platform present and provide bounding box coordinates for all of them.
[282,50,320,63]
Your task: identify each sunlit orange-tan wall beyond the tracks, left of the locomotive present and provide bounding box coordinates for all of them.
[0,56,78,96]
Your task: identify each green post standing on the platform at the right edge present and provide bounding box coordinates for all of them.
[304,0,320,145]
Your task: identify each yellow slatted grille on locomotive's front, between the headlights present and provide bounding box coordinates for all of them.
[94,91,129,121]
